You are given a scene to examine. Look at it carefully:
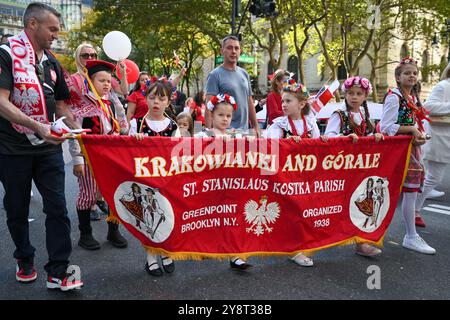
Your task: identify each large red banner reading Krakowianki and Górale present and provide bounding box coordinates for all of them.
[79,135,411,259]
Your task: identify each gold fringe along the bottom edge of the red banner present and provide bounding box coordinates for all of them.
[144,236,384,260]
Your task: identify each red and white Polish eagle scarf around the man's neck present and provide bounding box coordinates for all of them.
[3,31,49,135]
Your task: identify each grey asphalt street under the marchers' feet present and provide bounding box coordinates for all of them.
[0,142,450,300]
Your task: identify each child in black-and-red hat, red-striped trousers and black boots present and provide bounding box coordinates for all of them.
[70,60,127,250]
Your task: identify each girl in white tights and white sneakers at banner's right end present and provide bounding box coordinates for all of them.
[380,57,436,254]
